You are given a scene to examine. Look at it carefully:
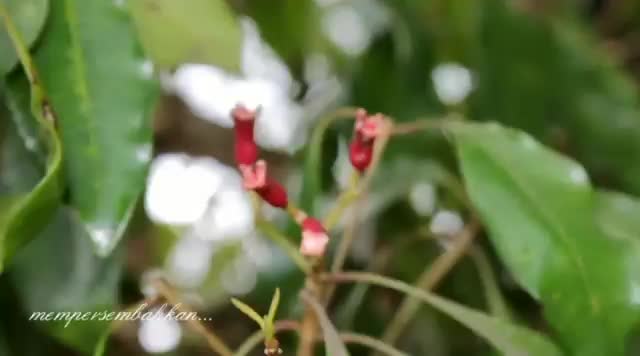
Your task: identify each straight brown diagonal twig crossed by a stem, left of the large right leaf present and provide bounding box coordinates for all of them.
[382,219,479,352]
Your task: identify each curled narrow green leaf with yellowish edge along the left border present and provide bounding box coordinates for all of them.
[0,4,63,271]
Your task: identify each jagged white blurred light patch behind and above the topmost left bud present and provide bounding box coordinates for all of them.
[163,19,306,152]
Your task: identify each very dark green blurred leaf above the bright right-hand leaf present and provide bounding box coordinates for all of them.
[468,0,640,194]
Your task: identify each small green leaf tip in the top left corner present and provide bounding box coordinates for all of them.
[0,0,49,76]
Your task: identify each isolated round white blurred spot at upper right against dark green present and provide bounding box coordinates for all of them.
[431,62,473,105]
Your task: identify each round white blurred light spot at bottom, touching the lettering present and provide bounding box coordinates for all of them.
[138,317,182,354]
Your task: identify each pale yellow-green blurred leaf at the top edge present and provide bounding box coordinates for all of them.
[131,0,242,72]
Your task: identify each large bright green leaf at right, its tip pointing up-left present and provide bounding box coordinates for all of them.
[452,124,640,356]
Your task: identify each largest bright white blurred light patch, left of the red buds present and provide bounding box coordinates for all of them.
[145,153,240,225]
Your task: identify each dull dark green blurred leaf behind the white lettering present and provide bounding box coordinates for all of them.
[8,208,124,354]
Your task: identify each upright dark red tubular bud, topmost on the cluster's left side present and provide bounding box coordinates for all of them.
[231,105,260,165]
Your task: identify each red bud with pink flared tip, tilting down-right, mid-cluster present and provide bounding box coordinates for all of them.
[238,160,289,208]
